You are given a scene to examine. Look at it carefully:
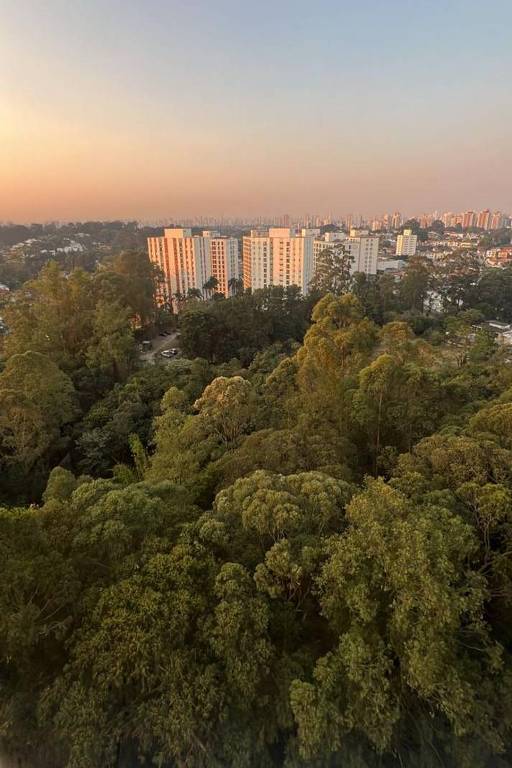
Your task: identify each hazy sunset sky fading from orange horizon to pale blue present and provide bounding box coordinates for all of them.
[0,0,512,222]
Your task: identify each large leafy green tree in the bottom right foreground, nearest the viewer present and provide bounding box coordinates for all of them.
[291,481,508,765]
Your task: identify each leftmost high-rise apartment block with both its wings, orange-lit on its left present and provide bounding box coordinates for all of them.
[148,227,239,303]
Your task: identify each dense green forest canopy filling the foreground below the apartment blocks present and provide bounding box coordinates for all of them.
[0,251,512,768]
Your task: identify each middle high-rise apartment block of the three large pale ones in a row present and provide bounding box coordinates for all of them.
[243,227,314,294]
